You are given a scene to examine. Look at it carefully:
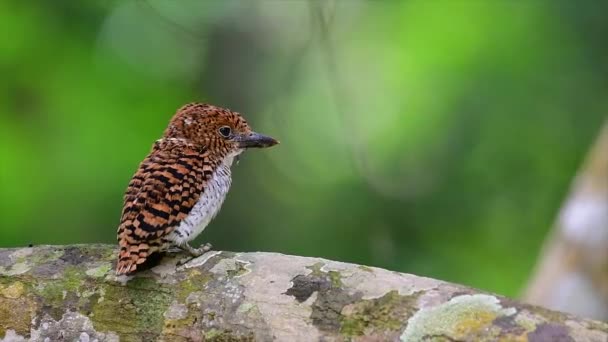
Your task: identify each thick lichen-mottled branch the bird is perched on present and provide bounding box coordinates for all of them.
[0,245,608,341]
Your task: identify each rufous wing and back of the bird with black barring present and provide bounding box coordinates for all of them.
[116,151,212,274]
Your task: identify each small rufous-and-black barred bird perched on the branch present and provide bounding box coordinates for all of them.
[116,103,279,275]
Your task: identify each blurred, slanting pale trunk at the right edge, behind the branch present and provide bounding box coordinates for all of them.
[524,120,608,321]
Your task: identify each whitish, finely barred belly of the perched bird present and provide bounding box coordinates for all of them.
[168,158,232,245]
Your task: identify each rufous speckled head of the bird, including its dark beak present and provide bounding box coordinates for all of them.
[164,103,279,156]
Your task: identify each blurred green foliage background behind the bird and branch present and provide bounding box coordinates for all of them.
[0,0,608,296]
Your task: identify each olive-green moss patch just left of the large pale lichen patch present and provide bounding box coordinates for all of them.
[340,291,421,337]
